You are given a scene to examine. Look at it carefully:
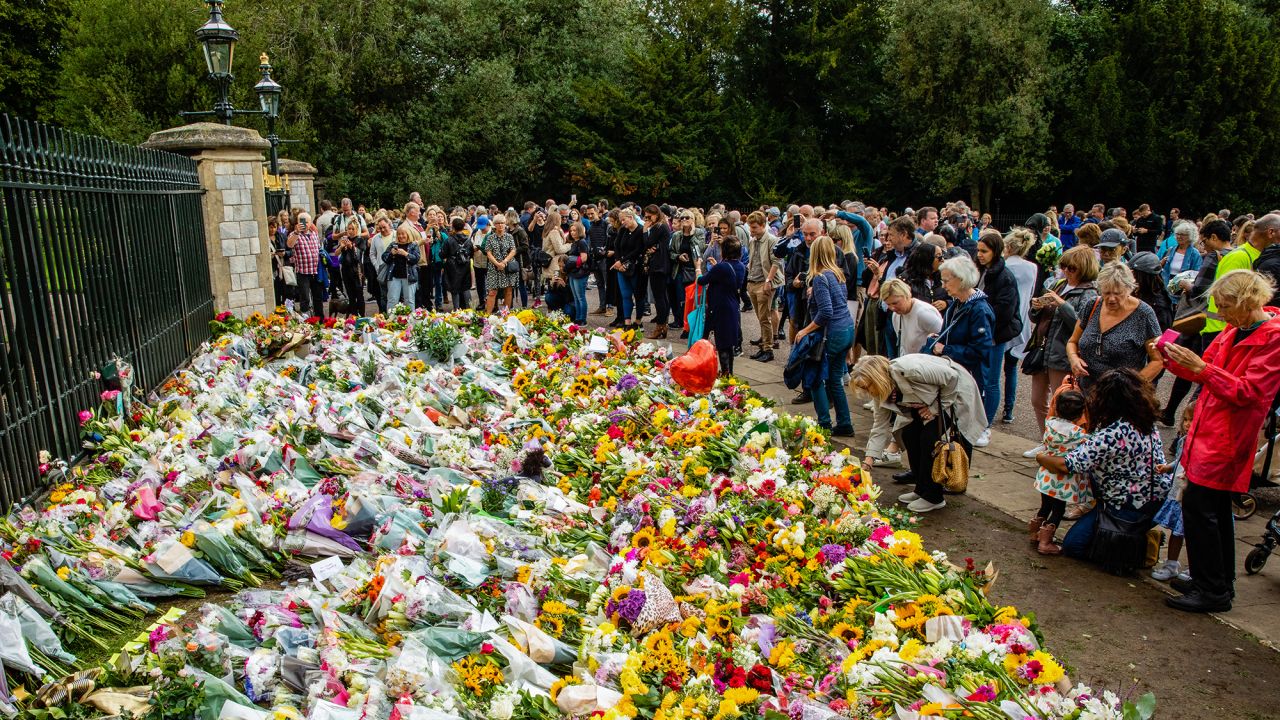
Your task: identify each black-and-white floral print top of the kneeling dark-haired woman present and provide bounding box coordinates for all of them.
[1065,420,1171,510]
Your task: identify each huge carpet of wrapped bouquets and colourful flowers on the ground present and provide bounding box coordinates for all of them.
[0,307,1152,720]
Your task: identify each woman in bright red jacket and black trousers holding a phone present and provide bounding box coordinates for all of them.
[1162,270,1280,612]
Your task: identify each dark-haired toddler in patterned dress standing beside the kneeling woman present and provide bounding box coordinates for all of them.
[1027,389,1092,555]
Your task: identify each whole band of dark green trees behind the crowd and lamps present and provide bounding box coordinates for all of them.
[15,0,1280,209]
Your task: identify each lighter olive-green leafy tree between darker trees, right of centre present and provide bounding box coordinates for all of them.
[886,0,1052,209]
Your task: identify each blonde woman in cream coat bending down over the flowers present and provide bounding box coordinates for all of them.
[850,354,987,512]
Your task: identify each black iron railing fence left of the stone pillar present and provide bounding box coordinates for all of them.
[0,115,214,510]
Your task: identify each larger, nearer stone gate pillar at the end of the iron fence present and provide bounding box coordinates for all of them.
[142,123,275,318]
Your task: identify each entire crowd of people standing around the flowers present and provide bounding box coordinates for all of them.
[270,193,1280,611]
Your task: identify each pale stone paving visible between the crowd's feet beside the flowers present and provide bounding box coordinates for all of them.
[576,302,1280,650]
